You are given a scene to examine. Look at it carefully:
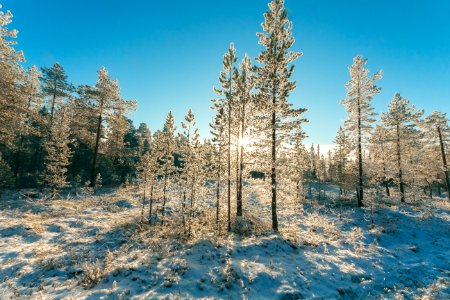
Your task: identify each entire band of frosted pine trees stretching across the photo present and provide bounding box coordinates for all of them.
[0,0,450,231]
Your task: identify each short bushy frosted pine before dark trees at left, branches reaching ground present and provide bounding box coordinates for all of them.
[43,106,71,198]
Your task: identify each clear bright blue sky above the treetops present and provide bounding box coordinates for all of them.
[1,0,450,144]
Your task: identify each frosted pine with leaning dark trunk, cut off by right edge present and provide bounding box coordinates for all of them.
[424,111,450,200]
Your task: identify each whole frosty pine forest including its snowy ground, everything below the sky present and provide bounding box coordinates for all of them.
[0,0,450,299]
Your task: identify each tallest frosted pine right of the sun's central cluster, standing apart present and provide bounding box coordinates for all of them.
[342,55,382,207]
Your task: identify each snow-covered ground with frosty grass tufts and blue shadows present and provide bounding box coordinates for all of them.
[0,186,450,299]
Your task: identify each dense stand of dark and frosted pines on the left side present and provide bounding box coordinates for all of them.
[0,6,140,193]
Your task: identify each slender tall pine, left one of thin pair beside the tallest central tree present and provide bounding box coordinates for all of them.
[212,43,237,231]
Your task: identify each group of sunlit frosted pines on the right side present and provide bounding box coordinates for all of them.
[329,56,450,206]
